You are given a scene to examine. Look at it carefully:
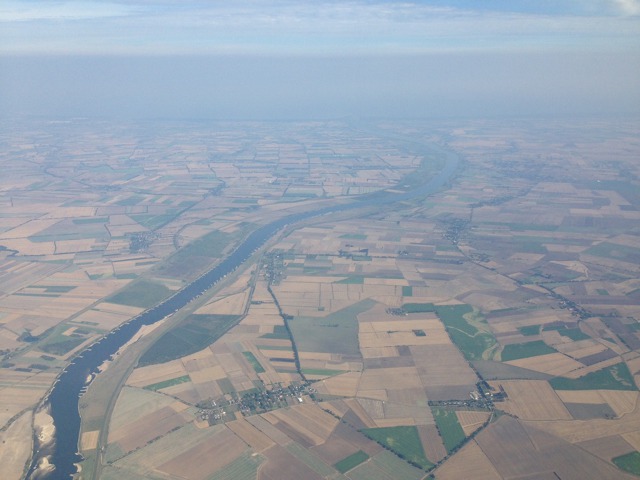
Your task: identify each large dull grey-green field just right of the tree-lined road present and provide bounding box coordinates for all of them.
[289,299,375,355]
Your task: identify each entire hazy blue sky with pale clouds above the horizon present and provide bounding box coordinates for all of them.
[0,0,640,119]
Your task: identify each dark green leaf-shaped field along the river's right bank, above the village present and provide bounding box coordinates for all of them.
[139,315,239,366]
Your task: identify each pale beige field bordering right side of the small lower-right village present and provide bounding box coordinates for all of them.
[490,380,572,420]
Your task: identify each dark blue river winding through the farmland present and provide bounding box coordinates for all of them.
[27,141,460,480]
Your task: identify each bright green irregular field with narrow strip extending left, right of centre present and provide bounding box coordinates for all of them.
[402,303,497,360]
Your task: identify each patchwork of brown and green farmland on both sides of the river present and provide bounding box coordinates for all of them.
[0,120,640,480]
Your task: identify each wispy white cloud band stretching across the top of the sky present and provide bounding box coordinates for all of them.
[0,0,640,54]
